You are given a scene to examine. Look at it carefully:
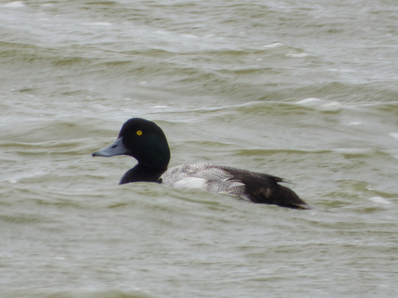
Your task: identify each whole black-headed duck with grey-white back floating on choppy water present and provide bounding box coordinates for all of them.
[92,118,310,209]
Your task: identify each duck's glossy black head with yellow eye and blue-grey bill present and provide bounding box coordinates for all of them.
[92,118,170,169]
